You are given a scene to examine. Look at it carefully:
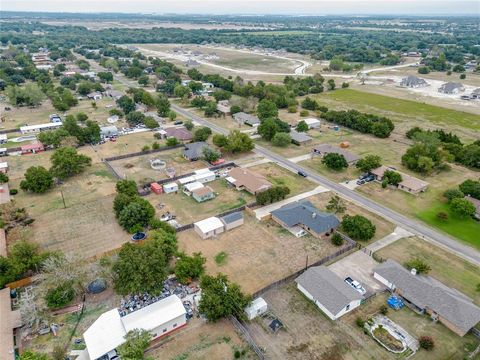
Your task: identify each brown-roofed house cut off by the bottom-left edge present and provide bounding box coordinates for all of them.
[0,287,23,360]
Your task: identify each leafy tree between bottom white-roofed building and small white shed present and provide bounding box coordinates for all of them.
[199,274,251,321]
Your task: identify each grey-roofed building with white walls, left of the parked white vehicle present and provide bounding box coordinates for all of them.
[295,266,362,320]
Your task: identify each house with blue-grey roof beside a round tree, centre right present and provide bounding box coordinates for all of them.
[271,200,340,238]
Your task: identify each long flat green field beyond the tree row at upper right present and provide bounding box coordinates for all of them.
[317,89,480,130]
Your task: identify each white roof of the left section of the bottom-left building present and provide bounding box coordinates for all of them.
[83,308,127,359]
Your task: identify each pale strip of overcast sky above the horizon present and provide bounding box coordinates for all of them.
[0,0,480,17]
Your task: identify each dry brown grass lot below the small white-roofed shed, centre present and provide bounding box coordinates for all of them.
[178,213,337,293]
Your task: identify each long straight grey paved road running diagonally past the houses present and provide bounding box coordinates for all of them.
[172,104,480,265]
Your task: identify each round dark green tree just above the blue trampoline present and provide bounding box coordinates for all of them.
[118,197,155,233]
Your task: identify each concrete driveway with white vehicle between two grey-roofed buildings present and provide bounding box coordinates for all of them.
[328,251,383,296]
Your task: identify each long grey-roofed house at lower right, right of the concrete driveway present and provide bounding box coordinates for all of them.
[373,259,480,336]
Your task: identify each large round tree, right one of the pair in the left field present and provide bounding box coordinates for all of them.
[50,147,92,180]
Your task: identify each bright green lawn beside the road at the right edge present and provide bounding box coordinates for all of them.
[417,203,480,249]
